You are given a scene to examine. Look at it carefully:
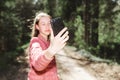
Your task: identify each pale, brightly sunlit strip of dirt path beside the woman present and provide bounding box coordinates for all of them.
[56,46,97,80]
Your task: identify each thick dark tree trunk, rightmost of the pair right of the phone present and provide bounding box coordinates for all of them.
[90,0,99,47]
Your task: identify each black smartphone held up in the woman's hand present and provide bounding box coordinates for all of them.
[51,17,65,36]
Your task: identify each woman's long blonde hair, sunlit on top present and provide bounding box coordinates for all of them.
[31,12,51,37]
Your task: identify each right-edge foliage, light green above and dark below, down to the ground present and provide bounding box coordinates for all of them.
[98,1,120,62]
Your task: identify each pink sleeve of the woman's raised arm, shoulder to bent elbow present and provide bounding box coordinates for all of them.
[30,40,52,71]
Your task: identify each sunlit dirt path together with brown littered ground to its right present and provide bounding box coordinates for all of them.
[56,47,120,80]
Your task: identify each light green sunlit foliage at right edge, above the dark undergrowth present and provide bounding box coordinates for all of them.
[99,2,120,44]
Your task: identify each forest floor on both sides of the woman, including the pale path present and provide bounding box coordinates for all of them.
[0,46,120,80]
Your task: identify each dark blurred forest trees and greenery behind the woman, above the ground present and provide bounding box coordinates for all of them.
[0,0,120,79]
